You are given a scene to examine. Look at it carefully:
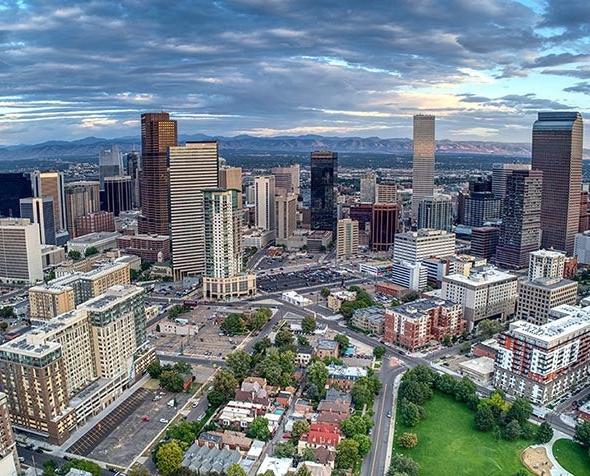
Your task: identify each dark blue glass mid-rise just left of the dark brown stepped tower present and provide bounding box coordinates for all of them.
[457,178,502,227]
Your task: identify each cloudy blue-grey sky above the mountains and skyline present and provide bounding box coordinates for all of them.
[0,0,590,147]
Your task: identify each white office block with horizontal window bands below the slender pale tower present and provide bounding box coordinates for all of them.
[393,229,455,263]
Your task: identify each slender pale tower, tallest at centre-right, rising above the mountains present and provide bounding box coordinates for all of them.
[412,114,436,216]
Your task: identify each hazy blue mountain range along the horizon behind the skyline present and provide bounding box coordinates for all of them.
[0,134,531,160]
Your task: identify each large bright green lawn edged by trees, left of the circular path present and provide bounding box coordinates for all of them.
[395,392,529,476]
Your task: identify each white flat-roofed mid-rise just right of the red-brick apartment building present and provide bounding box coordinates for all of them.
[442,267,518,328]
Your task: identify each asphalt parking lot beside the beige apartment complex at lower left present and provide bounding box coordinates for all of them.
[68,388,190,466]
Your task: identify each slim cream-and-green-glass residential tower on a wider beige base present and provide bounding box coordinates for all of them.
[203,189,256,299]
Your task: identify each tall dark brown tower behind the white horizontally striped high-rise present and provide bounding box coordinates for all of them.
[137,112,176,235]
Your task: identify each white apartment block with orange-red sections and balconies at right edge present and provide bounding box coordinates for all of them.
[494,305,590,405]
